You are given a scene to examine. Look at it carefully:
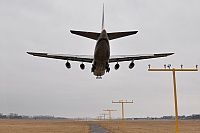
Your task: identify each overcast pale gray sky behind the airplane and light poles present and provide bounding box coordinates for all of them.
[0,0,200,117]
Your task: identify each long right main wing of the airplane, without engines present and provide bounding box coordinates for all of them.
[109,53,174,63]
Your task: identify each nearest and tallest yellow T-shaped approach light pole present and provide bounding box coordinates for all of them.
[148,64,198,133]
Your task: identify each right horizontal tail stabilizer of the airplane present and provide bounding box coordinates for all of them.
[108,31,138,40]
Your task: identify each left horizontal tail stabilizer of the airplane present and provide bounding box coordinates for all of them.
[70,30,100,40]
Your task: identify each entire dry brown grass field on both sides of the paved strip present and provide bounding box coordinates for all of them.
[0,119,200,133]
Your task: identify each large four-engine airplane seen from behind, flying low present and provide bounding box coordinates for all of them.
[27,5,174,79]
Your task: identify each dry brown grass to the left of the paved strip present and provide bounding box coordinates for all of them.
[0,120,90,133]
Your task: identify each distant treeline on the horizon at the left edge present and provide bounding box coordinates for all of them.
[0,113,67,120]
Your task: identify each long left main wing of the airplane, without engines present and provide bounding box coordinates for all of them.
[27,52,93,63]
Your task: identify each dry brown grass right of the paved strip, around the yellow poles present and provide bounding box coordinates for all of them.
[101,120,200,133]
